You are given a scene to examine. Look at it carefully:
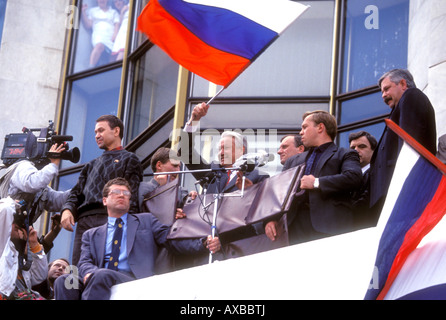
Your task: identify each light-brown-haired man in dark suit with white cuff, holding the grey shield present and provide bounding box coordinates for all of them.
[265,111,362,244]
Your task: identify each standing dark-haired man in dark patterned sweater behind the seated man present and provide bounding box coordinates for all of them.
[61,115,142,265]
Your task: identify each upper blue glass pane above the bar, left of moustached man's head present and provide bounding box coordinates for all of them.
[342,0,409,92]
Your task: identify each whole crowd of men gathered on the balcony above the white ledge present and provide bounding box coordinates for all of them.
[0,69,441,299]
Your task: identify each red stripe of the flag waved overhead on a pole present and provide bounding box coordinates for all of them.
[137,0,250,87]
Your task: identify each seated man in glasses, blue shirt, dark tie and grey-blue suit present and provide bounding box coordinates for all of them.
[54,178,220,300]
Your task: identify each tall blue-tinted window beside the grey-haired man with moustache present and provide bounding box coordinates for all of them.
[335,0,409,146]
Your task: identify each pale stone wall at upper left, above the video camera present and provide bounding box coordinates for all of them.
[0,0,70,150]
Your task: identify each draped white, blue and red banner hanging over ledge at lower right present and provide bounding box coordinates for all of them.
[365,120,446,299]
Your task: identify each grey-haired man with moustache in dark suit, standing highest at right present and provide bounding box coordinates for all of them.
[370,69,437,214]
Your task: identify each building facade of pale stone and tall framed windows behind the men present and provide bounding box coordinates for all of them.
[0,0,446,264]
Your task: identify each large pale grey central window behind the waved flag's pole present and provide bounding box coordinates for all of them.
[186,1,334,182]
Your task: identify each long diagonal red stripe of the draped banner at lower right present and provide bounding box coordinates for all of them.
[377,176,446,300]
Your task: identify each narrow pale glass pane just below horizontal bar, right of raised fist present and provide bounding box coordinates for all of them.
[190,103,329,129]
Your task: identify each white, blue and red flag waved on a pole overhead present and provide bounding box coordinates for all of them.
[137,0,307,87]
